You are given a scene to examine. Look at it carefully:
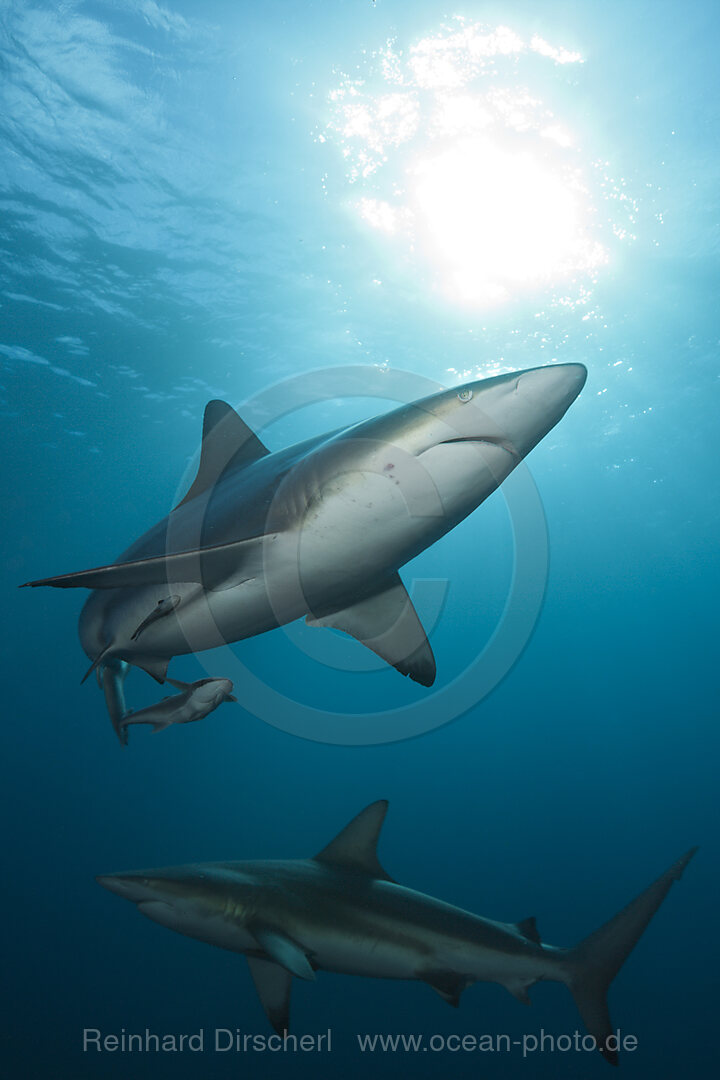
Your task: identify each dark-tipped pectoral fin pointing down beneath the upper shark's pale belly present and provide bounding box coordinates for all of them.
[305,573,435,686]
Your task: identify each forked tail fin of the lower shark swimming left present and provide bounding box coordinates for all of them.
[565,848,697,1065]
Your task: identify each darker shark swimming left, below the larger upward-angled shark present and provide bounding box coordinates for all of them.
[97,800,696,1065]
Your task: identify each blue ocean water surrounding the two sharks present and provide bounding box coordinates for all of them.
[0,0,720,1080]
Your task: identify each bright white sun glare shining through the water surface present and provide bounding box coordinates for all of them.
[318,17,631,307]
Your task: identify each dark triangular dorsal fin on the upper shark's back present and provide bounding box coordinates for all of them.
[176,401,270,509]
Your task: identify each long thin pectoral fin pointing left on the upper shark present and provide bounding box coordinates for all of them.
[22,534,276,589]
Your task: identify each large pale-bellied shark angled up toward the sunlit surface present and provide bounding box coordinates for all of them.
[22,364,587,729]
